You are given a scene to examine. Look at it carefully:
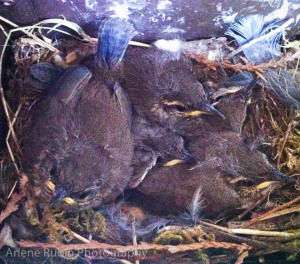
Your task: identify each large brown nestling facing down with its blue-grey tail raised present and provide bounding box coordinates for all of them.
[22,20,133,211]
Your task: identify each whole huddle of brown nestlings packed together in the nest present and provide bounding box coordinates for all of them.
[11,18,293,223]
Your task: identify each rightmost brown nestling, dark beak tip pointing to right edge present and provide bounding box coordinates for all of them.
[187,131,295,183]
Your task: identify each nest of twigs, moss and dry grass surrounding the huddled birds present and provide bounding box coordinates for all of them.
[0,17,300,263]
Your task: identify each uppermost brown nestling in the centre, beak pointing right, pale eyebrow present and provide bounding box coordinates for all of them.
[122,47,221,129]
